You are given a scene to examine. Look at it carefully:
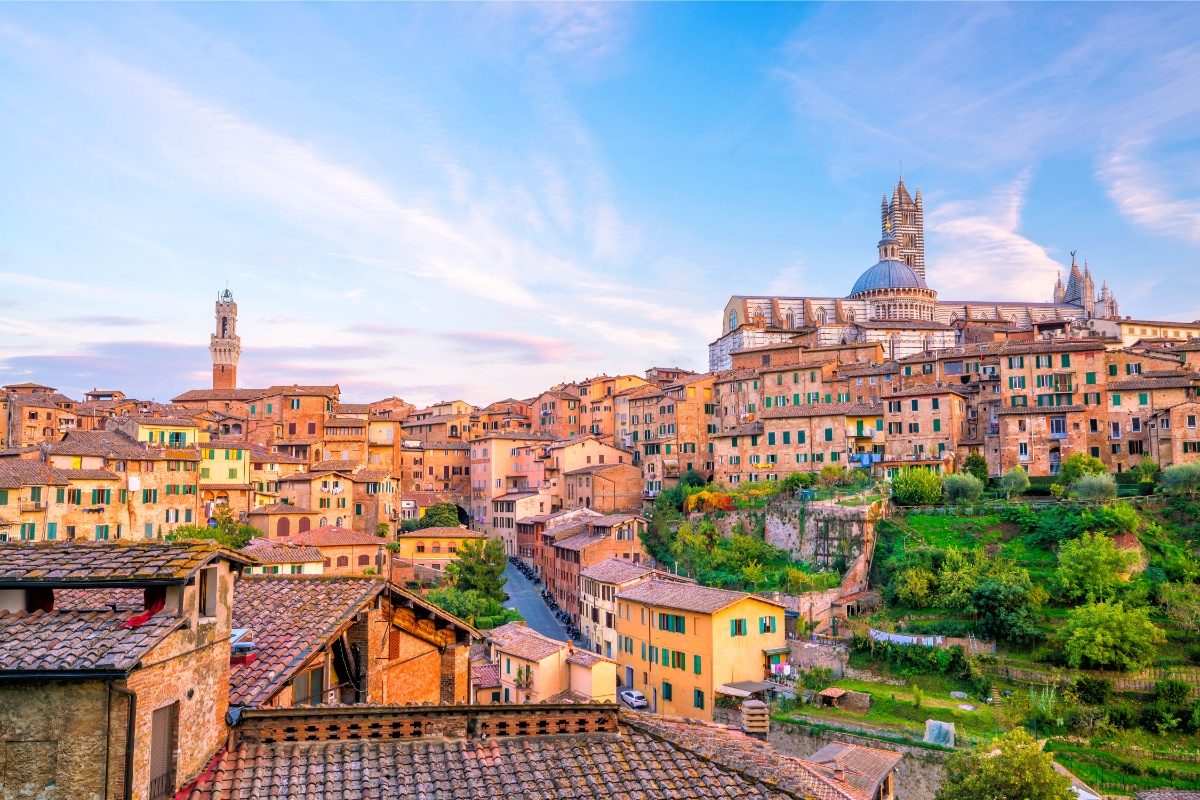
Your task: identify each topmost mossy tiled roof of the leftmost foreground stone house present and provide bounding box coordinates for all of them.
[0,540,248,587]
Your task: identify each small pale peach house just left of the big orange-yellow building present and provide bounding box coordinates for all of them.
[474,622,617,703]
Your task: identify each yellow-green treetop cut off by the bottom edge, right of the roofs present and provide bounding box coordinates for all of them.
[934,728,1075,800]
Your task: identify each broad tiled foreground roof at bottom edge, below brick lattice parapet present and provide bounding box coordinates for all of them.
[187,704,864,800]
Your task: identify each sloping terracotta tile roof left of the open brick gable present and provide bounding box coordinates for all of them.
[229,575,384,705]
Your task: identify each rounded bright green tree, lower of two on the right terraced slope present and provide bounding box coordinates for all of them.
[1058,602,1166,670]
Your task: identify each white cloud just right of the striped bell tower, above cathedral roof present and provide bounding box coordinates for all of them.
[928,170,1062,300]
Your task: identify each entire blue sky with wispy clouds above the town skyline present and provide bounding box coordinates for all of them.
[0,4,1200,403]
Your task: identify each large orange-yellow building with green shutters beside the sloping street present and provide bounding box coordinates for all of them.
[616,581,788,720]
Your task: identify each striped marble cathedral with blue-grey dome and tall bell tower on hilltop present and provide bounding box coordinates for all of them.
[708,179,1117,372]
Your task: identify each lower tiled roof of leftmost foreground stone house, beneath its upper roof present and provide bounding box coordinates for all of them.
[0,610,184,673]
